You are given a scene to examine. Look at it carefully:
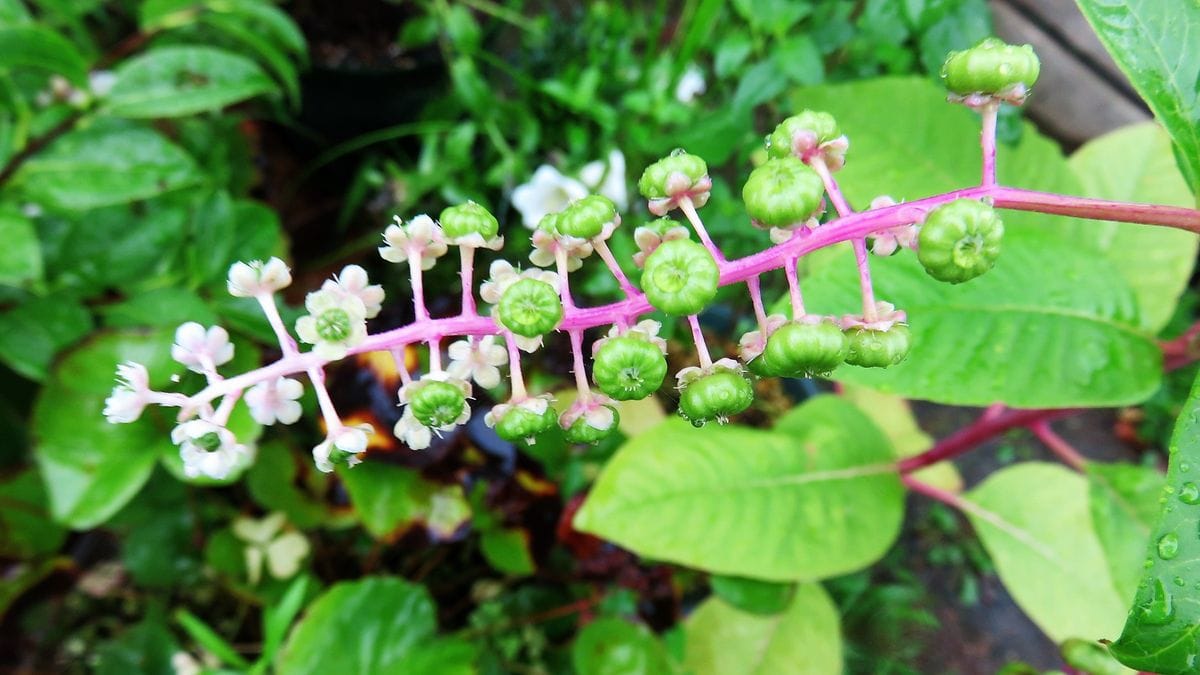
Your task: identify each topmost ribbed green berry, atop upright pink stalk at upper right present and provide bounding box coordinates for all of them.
[942,37,1042,94]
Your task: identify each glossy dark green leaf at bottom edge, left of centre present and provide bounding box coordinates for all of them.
[276,577,474,675]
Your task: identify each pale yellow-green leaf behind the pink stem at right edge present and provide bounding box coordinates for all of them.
[1058,123,1200,333]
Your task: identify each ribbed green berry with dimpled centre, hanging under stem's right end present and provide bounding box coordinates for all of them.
[917,199,1004,283]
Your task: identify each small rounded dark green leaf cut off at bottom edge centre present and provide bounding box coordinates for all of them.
[571,619,676,675]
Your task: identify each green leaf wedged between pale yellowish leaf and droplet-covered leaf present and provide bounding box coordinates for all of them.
[1087,462,1163,603]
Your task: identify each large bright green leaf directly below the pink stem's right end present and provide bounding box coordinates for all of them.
[804,241,1162,407]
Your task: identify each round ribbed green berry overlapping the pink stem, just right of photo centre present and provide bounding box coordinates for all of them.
[642,239,721,315]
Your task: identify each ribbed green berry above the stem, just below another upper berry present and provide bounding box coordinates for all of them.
[742,156,824,228]
